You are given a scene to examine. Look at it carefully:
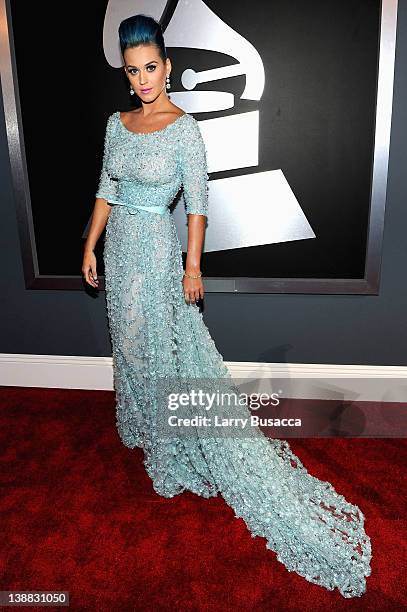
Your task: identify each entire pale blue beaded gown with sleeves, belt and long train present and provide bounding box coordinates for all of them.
[96,111,371,598]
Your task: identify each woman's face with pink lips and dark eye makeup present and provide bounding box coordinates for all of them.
[123,45,171,102]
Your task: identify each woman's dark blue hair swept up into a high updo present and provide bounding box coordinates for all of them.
[119,13,167,62]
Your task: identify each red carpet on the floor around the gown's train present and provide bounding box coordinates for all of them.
[0,387,407,612]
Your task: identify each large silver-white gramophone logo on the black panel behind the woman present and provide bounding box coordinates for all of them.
[103,0,315,252]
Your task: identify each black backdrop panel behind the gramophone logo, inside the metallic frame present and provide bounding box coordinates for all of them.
[10,0,381,278]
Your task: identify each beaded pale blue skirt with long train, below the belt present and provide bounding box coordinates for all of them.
[104,206,371,598]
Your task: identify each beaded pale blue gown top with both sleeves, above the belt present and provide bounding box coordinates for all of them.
[96,111,208,215]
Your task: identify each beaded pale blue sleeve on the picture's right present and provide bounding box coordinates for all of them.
[179,117,209,216]
